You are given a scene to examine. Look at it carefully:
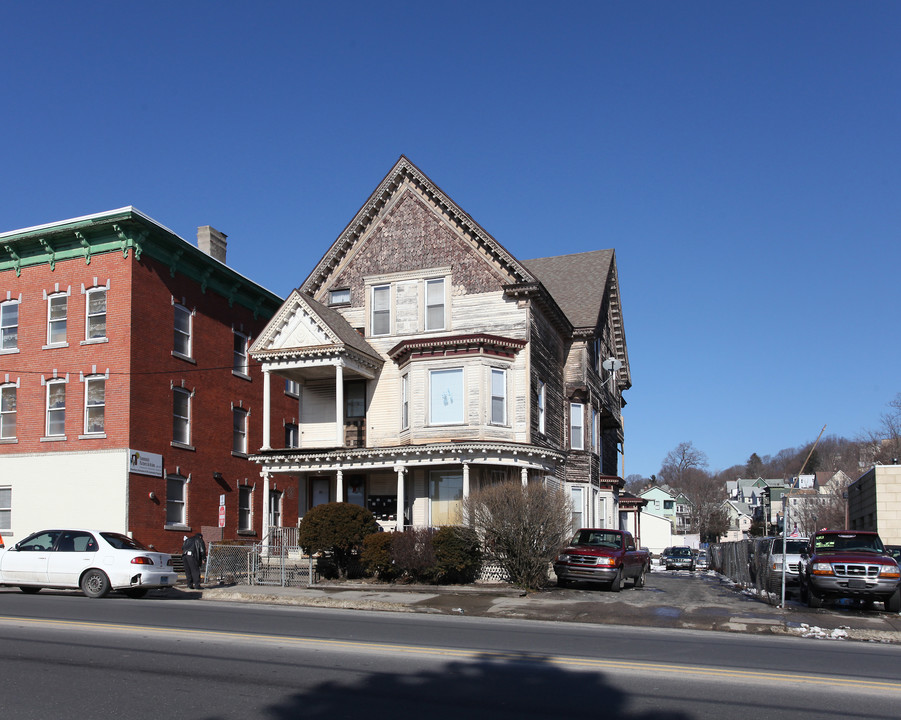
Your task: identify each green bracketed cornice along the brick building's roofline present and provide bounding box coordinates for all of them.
[0,207,282,317]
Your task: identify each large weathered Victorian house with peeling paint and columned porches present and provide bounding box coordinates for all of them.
[250,157,631,530]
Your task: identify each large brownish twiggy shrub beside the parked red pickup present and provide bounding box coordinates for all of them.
[463,483,572,590]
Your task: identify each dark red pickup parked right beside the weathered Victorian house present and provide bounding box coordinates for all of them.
[554,528,651,592]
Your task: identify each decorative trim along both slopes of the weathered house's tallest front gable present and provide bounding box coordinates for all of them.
[300,155,535,301]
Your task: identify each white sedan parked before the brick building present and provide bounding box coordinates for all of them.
[0,530,176,598]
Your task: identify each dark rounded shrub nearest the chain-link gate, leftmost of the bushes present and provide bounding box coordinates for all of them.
[298,503,379,577]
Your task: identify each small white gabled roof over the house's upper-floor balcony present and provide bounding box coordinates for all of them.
[250,290,384,367]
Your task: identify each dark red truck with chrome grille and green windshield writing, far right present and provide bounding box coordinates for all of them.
[799,530,901,612]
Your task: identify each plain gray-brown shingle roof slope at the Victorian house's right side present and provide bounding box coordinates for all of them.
[520,250,613,328]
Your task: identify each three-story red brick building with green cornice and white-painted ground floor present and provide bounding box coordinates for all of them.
[0,207,298,552]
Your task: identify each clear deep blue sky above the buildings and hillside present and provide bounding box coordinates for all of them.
[0,0,901,475]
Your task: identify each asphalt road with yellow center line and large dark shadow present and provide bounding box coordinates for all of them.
[0,591,901,720]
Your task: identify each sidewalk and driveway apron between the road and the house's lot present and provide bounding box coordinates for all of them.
[186,572,901,643]
